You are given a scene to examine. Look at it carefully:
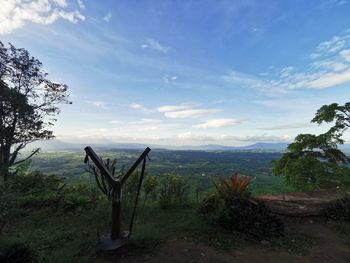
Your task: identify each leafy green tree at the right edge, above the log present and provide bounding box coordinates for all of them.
[273,103,350,190]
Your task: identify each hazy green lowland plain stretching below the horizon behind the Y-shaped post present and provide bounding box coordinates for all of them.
[32,148,283,196]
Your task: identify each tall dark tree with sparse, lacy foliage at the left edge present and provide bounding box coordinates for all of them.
[0,41,70,182]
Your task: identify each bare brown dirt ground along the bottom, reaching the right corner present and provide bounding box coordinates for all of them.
[94,222,350,263]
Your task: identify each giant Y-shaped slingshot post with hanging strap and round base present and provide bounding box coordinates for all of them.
[84,146,151,251]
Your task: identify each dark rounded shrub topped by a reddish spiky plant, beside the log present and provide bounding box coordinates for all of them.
[199,173,284,240]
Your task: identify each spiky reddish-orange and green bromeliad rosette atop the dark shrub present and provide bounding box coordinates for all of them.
[213,172,254,200]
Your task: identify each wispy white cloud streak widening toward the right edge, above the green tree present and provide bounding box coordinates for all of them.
[223,30,350,92]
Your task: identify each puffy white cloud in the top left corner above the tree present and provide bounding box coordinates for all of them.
[0,0,85,34]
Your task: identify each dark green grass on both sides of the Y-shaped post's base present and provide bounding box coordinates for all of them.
[0,200,240,262]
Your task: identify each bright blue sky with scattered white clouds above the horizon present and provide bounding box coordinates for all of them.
[0,0,350,146]
